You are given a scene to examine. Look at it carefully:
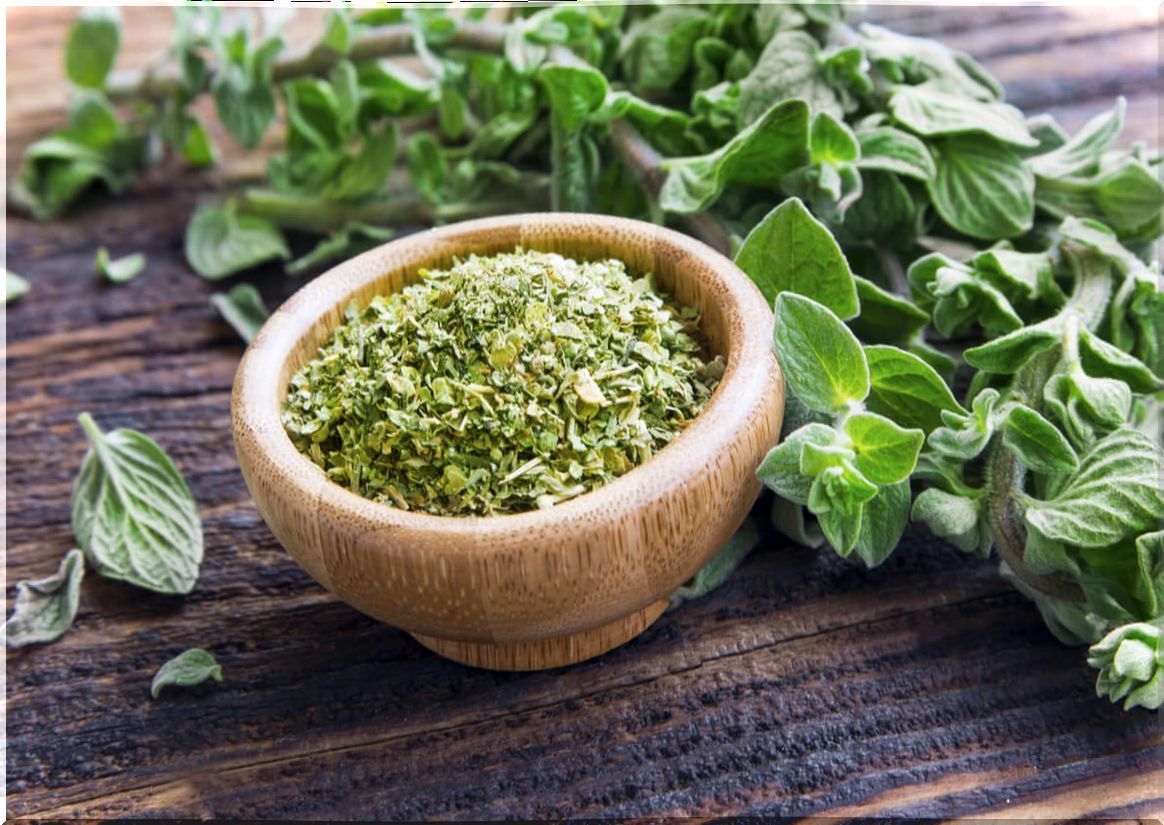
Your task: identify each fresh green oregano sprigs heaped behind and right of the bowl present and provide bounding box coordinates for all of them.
[9,2,1164,707]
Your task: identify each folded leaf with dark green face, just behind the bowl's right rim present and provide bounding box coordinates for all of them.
[659,100,808,213]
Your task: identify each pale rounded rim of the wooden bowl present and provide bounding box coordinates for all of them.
[232,213,783,547]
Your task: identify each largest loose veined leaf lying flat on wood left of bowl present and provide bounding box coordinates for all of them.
[72,412,203,593]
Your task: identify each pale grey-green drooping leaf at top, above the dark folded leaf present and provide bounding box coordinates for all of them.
[737,31,844,129]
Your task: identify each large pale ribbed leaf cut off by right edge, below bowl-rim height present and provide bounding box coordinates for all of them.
[1025,428,1164,547]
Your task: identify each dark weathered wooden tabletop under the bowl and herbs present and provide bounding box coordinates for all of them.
[7,7,1164,819]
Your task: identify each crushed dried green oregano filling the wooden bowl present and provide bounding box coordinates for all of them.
[283,249,724,515]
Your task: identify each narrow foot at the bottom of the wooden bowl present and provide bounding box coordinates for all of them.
[410,599,667,670]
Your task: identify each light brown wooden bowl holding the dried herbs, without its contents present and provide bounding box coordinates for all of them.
[232,214,785,670]
